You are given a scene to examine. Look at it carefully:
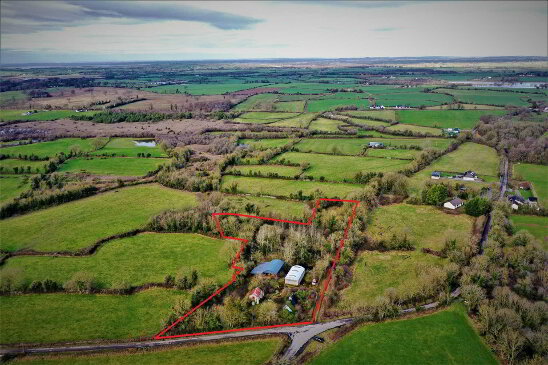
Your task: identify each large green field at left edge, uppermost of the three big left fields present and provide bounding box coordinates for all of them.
[0,184,196,251]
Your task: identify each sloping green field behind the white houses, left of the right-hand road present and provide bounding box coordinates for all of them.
[414,142,499,182]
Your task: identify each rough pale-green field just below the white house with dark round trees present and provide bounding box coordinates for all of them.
[368,204,475,250]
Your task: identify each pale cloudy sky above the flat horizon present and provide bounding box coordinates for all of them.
[0,0,548,64]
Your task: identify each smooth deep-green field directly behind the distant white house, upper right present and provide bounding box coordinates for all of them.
[396,110,506,129]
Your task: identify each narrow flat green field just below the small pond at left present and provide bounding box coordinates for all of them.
[58,157,169,176]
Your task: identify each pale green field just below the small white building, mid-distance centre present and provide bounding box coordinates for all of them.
[272,152,409,181]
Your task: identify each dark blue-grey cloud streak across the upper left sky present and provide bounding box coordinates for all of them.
[1,1,262,34]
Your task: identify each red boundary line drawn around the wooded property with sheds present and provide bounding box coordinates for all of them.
[154,198,360,340]
